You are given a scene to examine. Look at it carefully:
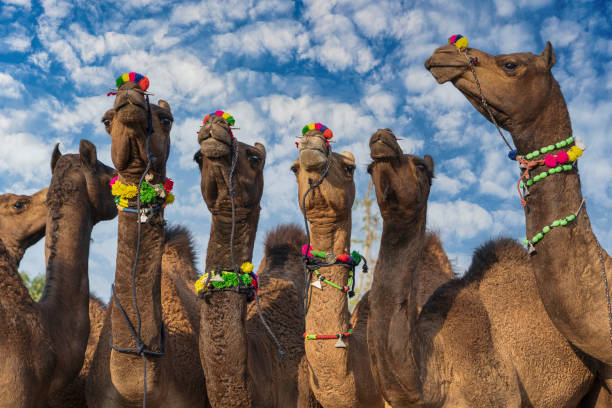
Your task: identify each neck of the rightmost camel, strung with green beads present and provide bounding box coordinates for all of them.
[512,83,612,364]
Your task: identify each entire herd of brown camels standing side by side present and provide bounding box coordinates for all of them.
[0,38,612,408]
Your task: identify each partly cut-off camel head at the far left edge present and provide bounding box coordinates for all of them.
[0,188,48,261]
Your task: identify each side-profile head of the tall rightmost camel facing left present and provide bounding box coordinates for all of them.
[425,42,559,134]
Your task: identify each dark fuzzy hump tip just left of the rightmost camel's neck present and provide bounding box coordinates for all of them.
[466,237,528,280]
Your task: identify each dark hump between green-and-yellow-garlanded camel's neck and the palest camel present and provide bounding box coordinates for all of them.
[261,224,306,290]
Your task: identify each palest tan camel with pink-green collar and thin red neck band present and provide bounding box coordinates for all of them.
[291,129,383,408]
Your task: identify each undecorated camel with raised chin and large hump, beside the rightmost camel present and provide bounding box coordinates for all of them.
[368,129,598,408]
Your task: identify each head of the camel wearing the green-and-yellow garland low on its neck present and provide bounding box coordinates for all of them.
[194,111,266,219]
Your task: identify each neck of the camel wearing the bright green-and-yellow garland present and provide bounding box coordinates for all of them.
[199,206,259,407]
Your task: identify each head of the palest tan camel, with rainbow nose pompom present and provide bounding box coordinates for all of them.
[291,124,355,222]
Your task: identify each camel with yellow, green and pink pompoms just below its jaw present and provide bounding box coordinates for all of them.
[86,78,206,407]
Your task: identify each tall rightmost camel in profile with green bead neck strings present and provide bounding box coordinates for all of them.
[425,42,612,370]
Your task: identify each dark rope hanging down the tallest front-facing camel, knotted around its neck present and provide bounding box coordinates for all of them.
[110,94,166,408]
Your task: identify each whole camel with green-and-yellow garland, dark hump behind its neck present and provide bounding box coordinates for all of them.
[194,111,308,407]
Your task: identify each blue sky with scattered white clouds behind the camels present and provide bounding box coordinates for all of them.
[0,0,612,299]
